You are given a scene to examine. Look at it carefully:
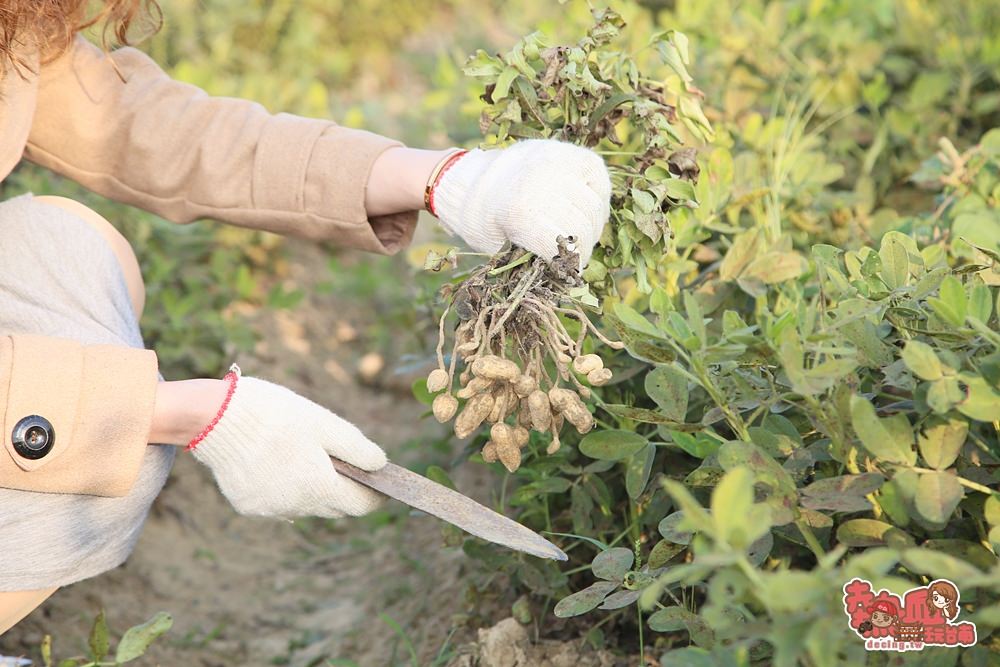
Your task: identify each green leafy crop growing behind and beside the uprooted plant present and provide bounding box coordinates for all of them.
[4,0,1000,665]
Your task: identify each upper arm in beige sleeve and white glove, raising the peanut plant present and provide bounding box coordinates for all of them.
[25,36,611,265]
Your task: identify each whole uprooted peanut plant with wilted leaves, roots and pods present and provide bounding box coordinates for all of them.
[427,9,710,472]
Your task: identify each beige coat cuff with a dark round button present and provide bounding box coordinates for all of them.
[0,334,159,496]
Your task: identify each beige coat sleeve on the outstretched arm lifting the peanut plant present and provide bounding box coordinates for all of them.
[25,36,417,254]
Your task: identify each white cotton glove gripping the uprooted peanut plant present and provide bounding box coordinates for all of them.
[434,139,611,268]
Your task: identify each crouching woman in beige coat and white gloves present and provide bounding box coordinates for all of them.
[0,0,610,632]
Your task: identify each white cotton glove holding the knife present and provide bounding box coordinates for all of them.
[191,369,386,518]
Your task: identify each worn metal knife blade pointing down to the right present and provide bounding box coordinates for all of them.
[330,456,568,560]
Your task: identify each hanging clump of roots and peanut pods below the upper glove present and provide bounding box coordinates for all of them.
[427,237,623,472]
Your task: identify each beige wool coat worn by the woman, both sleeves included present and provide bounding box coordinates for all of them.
[0,37,417,496]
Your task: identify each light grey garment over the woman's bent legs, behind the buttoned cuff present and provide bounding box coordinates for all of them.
[0,195,177,591]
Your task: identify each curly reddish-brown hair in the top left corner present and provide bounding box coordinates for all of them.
[0,0,163,76]
